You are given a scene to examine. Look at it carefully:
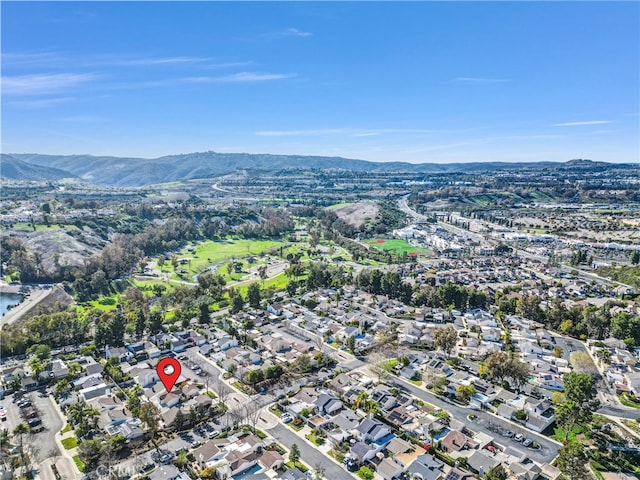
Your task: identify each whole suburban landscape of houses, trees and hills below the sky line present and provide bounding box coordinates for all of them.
[0,152,640,480]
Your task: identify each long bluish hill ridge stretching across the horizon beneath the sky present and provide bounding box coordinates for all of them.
[2,152,633,187]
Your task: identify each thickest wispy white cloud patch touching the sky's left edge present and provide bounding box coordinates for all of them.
[2,73,98,96]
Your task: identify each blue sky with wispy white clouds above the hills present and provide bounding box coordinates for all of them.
[1,2,640,163]
